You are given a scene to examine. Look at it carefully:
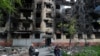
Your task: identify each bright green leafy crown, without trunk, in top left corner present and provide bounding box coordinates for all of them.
[0,0,21,14]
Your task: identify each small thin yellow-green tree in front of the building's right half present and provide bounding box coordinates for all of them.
[58,16,76,46]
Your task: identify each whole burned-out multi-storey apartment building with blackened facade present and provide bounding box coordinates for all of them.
[0,0,100,46]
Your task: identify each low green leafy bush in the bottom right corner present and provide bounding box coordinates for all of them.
[74,46,100,56]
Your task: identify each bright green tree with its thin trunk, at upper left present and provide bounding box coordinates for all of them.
[0,0,22,42]
